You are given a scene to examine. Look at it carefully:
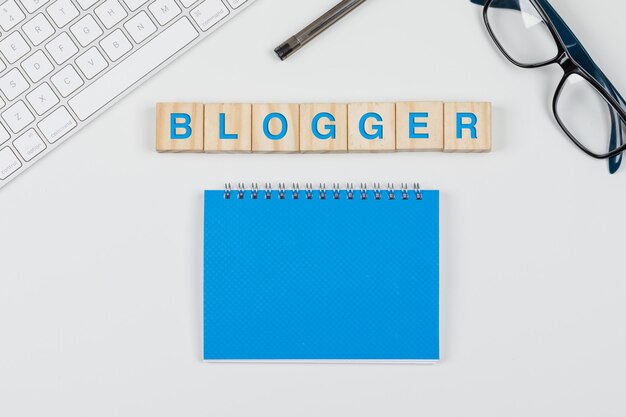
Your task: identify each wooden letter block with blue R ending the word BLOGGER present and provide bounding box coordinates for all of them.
[444,103,491,152]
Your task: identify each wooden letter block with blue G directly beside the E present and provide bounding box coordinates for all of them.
[348,103,396,152]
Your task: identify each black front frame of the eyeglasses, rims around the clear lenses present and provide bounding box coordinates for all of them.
[473,0,626,159]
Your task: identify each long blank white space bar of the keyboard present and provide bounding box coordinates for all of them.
[68,17,198,120]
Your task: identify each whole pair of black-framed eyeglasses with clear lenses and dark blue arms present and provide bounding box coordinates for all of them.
[471,0,626,173]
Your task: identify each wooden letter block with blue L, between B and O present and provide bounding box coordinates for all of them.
[204,104,252,153]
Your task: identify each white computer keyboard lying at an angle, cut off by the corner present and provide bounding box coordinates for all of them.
[0,0,254,188]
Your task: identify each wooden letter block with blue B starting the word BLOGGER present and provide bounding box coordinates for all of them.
[156,103,204,152]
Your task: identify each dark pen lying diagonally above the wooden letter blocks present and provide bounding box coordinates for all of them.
[274,0,365,61]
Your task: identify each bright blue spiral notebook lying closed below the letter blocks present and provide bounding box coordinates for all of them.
[204,188,439,362]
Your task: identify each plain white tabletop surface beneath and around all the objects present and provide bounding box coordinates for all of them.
[0,0,626,417]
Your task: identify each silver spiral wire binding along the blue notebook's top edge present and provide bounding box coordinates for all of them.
[224,182,424,201]
